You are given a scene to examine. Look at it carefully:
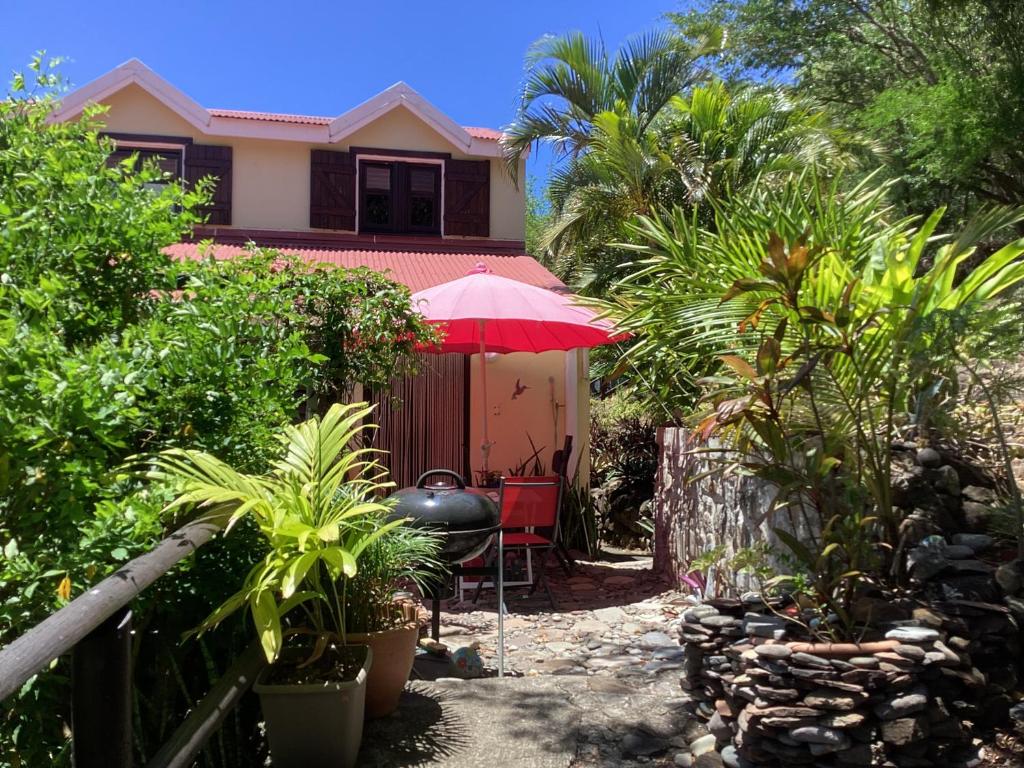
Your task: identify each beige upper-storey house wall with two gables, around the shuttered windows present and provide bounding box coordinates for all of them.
[94,85,526,241]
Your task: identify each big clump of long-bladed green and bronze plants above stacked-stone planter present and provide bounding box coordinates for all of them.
[608,178,1024,631]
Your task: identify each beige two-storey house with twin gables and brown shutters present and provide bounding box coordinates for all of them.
[53,59,589,484]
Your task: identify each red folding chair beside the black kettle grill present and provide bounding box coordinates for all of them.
[473,475,562,608]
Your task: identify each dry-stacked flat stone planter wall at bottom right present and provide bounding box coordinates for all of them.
[680,599,1016,768]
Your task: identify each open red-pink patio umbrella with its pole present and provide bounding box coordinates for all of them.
[413,264,628,471]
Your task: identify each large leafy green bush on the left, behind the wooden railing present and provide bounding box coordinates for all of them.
[0,60,432,765]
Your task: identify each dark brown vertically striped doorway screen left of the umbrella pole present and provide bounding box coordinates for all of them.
[369,354,472,488]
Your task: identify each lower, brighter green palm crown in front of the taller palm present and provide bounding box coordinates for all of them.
[542,81,856,294]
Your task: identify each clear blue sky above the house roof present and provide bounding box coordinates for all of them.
[0,0,683,188]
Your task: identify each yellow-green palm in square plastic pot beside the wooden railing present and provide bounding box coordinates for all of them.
[147,402,402,768]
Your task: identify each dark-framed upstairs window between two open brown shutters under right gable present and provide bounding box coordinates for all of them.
[359,160,441,234]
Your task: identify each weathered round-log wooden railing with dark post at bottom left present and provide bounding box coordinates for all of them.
[0,517,264,768]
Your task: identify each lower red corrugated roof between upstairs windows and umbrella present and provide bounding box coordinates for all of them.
[164,243,565,293]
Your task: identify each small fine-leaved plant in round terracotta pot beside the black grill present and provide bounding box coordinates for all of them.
[345,528,444,718]
